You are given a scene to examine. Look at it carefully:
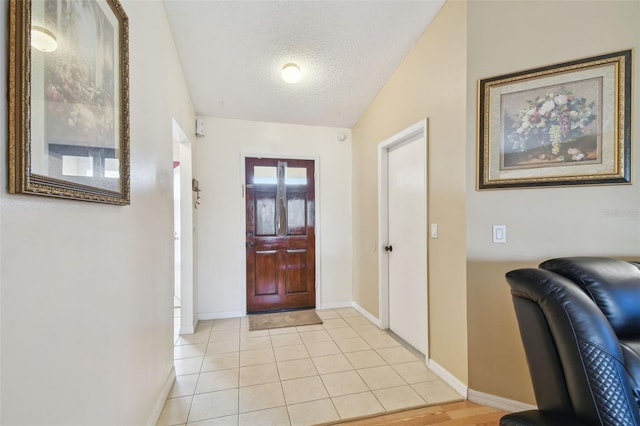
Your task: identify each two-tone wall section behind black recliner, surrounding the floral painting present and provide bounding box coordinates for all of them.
[464,1,640,403]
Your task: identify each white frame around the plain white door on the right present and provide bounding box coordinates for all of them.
[377,118,429,352]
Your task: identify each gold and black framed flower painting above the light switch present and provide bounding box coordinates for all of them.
[477,50,632,190]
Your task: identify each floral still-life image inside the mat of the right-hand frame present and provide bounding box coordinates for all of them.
[502,81,600,168]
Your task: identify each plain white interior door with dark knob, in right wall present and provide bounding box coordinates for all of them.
[387,134,427,355]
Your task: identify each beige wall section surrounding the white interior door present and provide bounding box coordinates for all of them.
[353,2,467,383]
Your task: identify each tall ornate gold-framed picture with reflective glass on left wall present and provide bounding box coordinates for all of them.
[8,0,130,205]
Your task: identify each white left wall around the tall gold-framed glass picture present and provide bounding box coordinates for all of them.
[0,0,195,425]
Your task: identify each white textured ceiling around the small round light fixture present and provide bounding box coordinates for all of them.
[164,0,445,128]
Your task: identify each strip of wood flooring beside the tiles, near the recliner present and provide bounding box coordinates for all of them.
[330,401,507,426]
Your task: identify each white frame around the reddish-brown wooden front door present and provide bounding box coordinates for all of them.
[238,152,322,315]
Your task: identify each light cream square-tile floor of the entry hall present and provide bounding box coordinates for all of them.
[158,308,462,426]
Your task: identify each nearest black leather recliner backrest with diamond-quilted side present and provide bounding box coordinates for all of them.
[506,268,640,426]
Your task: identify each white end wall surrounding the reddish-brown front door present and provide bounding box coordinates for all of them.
[194,118,352,319]
